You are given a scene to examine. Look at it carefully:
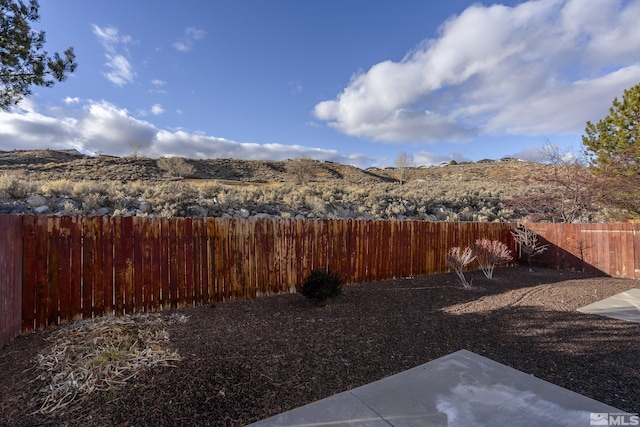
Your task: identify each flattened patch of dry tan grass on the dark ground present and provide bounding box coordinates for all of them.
[30,314,187,413]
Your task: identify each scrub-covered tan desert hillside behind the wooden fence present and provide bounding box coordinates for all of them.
[0,150,598,221]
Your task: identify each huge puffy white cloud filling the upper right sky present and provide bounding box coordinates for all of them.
[314,0,640,142]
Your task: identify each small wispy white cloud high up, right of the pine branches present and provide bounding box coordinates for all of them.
[92,25,135,87]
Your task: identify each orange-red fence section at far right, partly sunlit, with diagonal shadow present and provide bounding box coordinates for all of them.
[525,222,640,279]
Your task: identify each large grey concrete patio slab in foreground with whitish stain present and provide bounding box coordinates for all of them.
[250,350,630,427]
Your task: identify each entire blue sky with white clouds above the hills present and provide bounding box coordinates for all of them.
[0,0,640,167]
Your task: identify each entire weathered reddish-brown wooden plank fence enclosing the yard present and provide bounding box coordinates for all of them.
[0,216,640,345]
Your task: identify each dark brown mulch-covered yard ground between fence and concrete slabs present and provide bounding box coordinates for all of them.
[0,267,640,426]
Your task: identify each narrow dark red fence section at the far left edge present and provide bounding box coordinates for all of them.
[0,215,22,347]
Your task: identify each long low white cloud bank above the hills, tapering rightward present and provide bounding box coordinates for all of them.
[0,100,373,166]
